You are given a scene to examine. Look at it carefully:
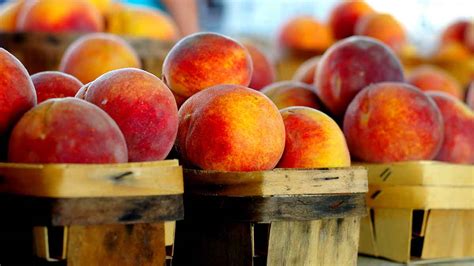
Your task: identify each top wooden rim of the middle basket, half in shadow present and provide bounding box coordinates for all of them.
[184,167,367,196]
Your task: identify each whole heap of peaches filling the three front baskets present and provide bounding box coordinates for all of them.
[0,0,474,171]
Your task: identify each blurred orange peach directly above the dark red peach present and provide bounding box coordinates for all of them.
[354,13,407,52]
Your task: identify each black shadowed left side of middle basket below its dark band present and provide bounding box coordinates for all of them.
[173,220,253,266]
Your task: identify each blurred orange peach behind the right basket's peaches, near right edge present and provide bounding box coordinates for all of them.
[407,65,464,100]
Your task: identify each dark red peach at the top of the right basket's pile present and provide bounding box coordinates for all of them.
[315,36,403,118]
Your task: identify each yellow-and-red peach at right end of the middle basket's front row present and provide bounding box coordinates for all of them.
[277,107,351,168]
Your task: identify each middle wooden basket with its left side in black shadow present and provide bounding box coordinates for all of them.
[173,167,367,266]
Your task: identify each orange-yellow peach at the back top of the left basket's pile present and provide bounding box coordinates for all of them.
[59,33,141,84]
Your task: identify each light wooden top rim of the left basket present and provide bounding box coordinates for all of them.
[0,160,184,198]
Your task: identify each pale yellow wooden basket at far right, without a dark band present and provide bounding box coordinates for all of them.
[359,161,474,262]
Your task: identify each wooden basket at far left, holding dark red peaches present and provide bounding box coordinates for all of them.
[0,160,184,265]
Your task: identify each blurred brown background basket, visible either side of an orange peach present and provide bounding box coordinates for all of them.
[0,32,173,77]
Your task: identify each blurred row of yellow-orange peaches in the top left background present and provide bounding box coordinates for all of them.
[0,0,180,41]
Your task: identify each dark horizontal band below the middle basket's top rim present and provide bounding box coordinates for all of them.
[185,193,367,222]
